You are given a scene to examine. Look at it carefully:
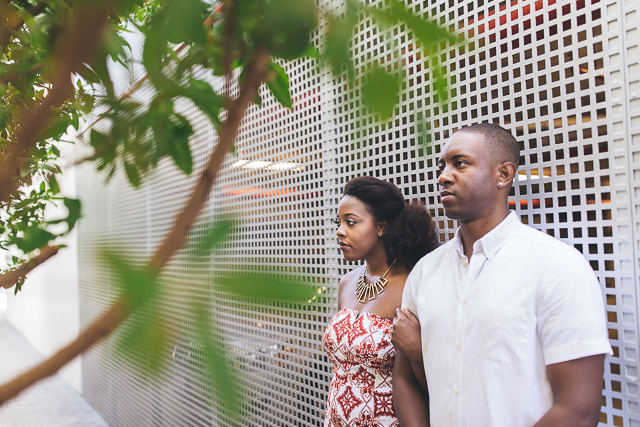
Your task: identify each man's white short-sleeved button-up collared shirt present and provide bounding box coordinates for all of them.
[402,212,612,427]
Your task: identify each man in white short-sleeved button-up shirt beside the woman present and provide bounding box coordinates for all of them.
[393,124,612,427]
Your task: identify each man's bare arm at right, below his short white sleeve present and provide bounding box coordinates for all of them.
[532,354,605,427]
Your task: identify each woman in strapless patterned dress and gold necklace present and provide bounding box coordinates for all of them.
[323,177,438,427]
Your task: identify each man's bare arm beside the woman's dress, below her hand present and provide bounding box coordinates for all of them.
[393,349,429,427]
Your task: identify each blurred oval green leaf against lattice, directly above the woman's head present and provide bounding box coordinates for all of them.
[362,67,400,120]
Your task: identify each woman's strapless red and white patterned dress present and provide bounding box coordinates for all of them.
[322,308,399,427]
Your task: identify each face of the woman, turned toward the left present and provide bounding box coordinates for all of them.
[336,196,384,261]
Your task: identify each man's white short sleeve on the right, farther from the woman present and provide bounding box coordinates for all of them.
[537,247,613,365]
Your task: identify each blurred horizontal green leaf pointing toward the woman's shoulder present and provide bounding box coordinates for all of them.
[220,272,316,302]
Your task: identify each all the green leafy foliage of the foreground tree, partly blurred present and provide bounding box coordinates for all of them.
[0,0,457,418]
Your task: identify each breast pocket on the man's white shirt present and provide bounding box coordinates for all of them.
[479,306,537,365]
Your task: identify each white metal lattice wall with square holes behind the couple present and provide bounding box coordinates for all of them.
[78,0,640,427]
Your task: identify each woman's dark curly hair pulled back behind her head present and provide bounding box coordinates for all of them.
[343,176,438,270]
